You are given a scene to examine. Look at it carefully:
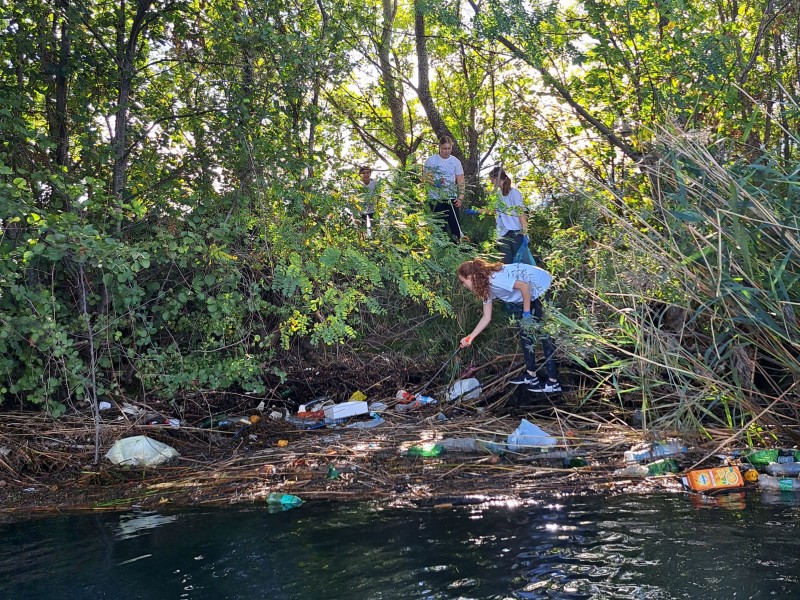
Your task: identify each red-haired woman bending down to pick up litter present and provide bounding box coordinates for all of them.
[457,258,561,393]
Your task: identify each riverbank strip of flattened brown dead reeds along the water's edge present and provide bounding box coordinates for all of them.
[0,390,752,514]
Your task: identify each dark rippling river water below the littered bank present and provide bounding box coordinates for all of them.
[0,492,800,600]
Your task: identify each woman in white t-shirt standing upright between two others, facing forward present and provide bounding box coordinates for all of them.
[425,136,464,239]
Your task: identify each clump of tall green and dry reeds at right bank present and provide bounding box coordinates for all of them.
[557,124,800,441]
